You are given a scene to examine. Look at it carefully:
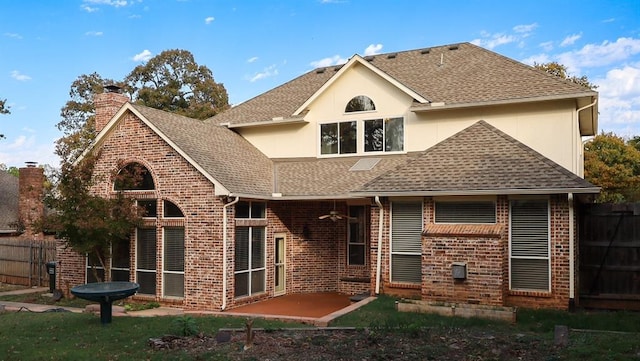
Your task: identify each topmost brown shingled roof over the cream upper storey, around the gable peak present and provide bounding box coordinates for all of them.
[209,43,597,127]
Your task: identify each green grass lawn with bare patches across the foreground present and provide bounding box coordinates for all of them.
[0,297,640,361]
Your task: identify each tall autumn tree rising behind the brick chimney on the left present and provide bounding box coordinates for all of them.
[56,50,229,162]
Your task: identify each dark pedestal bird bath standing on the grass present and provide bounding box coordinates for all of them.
[71,282,140,325]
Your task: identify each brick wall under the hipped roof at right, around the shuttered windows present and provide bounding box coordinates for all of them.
[370,195,577,309]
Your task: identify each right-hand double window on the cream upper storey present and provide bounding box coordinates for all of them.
[364,118,404,152]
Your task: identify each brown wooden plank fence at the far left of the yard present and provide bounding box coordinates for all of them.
[0,238,56,286]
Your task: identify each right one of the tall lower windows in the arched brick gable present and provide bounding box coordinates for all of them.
[162,227,184,297]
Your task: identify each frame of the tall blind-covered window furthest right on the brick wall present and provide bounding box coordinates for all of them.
[509,197,551,293]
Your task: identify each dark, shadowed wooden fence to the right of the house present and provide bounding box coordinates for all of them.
[578,203,640,310]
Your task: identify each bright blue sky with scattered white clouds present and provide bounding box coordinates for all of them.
[0,0,640,166]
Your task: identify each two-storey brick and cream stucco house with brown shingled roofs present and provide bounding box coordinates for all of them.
[59,43,599,310]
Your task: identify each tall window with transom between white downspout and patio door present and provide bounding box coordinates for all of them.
[234,202,266,297]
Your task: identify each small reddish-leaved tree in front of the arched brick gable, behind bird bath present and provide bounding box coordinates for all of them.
[39,154,142,281]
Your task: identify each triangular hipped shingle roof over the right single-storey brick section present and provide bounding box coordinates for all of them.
[354,121,599,196]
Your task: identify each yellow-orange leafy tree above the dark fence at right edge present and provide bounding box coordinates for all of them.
[584,133,640,203]
